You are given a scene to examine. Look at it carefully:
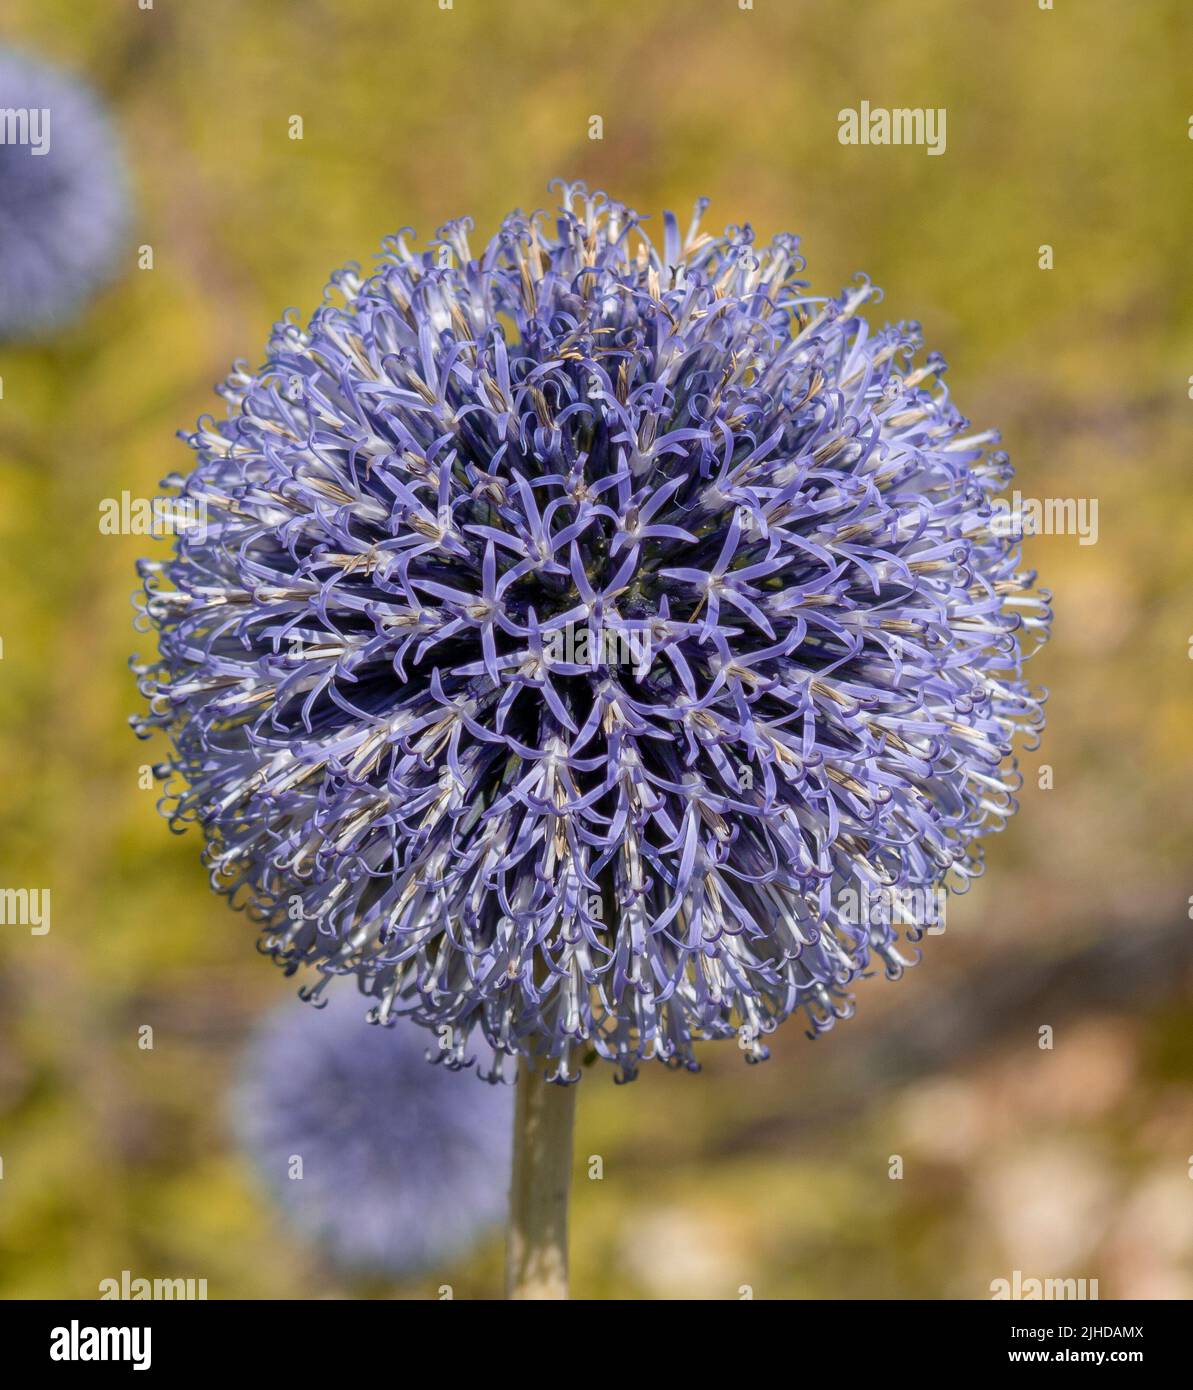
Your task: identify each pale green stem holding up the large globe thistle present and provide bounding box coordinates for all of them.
[505,1061,576,1298]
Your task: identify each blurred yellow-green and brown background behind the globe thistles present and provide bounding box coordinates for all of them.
[0,0,1193,1298]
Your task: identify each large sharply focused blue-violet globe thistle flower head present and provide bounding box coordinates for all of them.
[138,185,1048,1080]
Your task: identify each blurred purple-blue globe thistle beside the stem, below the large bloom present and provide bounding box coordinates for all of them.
[231,994,513,1275]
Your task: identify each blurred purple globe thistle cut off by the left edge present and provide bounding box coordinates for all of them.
[0,49,128,339]
